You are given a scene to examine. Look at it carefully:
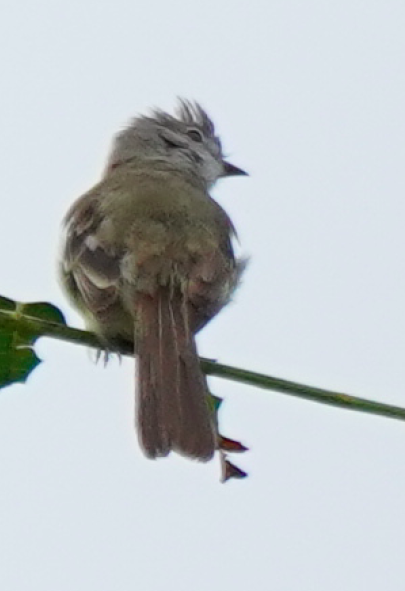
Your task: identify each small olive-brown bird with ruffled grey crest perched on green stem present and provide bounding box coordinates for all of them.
[59,100,246,461]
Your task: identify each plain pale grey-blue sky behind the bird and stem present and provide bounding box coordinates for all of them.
[0,0,405,591]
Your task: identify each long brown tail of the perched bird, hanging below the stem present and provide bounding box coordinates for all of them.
[135,287,216,461]
